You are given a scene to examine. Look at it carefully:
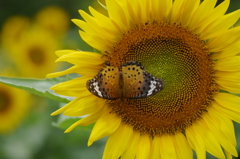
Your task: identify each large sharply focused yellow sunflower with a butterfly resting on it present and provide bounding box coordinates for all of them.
[48,0,240,159]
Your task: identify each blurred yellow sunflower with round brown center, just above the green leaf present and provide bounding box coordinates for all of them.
[9,28,58,78]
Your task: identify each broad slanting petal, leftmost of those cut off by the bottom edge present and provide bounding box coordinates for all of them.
[103,124,133,159]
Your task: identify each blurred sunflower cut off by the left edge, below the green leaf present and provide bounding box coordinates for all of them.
[0,75,31,134]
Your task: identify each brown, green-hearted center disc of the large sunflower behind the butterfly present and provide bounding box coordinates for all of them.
[109,22,218,135]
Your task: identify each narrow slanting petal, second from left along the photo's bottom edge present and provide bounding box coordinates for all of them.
[121,131,140,159]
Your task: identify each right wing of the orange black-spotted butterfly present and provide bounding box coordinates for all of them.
[122,61,164,99]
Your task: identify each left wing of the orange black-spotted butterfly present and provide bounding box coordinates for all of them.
[87,66,119,100]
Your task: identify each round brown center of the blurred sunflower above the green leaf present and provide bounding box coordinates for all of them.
[28,47,45,65]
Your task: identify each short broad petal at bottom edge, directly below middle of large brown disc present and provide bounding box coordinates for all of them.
[160,135,177,159]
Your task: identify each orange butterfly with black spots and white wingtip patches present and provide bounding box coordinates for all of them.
[86,61,165,100]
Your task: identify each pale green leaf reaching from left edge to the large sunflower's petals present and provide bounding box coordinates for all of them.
[0,76,72,103]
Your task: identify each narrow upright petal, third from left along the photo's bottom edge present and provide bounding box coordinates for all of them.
[136,134,151,159]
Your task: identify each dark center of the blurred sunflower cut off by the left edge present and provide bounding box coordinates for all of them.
[0,90,11,113]
